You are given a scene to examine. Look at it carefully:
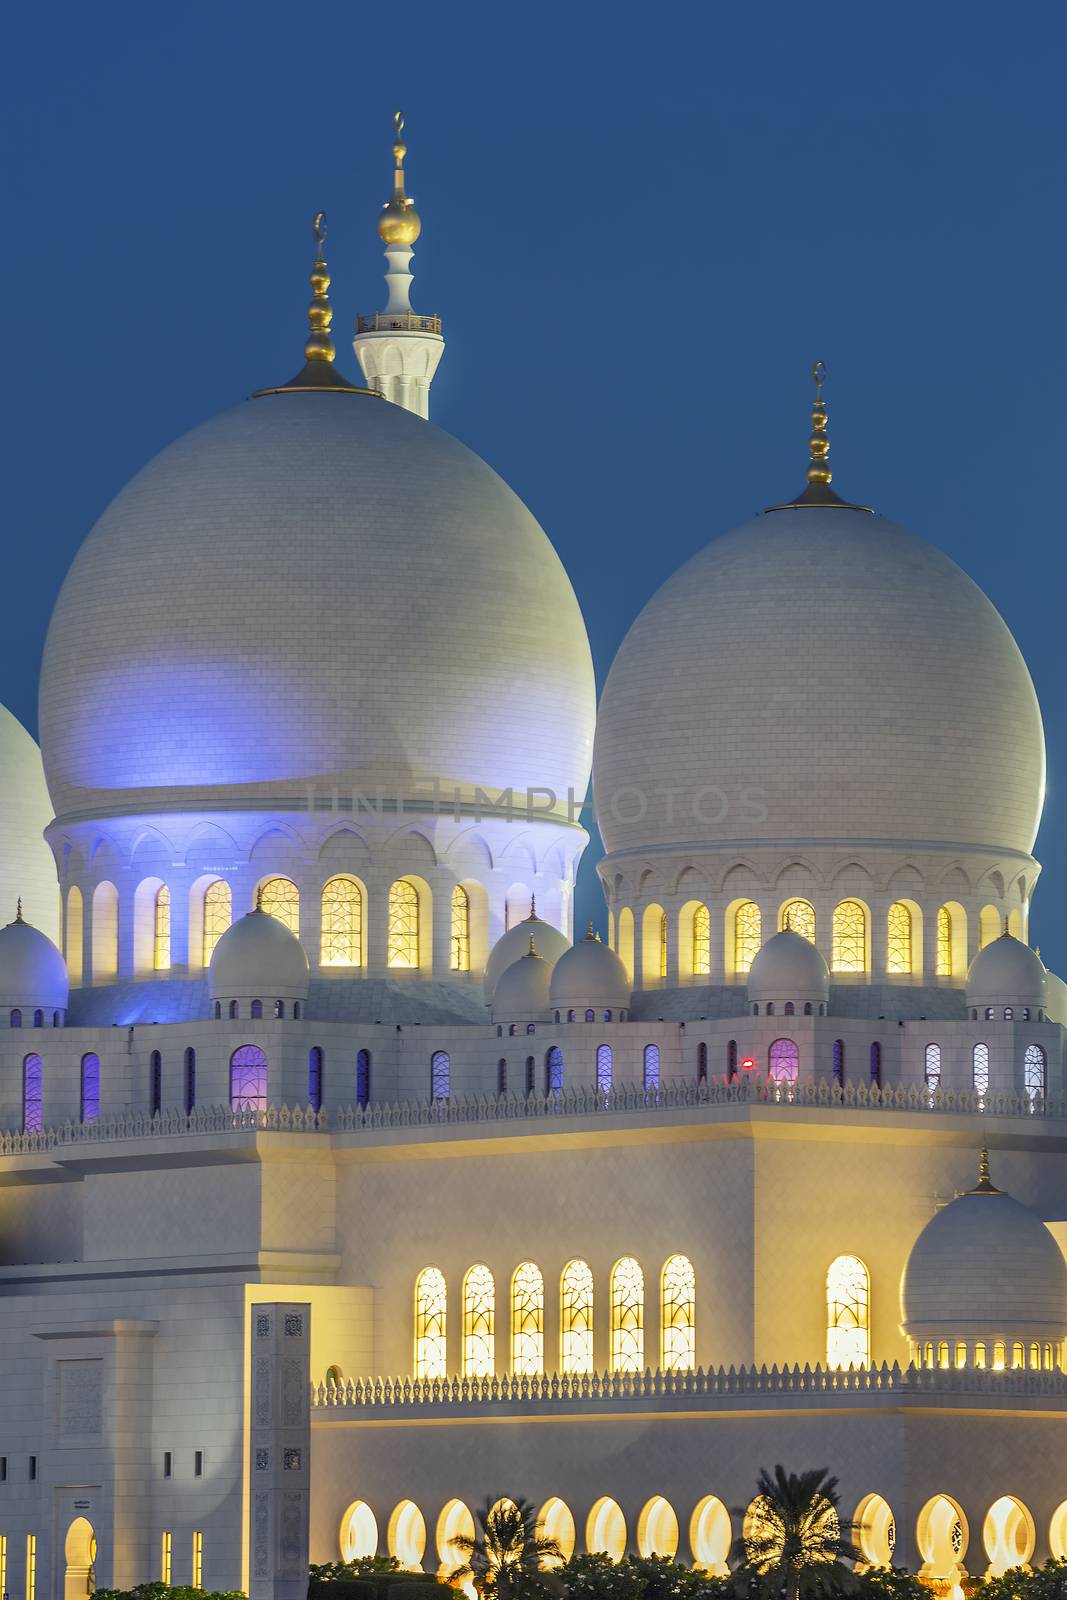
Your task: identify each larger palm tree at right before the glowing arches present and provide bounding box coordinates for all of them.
[734,1466,859,1600]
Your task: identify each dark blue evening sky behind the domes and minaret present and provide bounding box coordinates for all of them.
[0,0,1067,971]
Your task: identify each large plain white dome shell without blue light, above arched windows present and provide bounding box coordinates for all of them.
[593,507,1045,854]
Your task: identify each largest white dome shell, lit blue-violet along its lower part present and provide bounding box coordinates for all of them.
[34,392,595,825]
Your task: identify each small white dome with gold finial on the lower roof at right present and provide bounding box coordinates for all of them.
[901,1158,1067,1358]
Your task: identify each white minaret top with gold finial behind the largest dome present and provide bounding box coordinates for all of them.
[352,112,445,418]
